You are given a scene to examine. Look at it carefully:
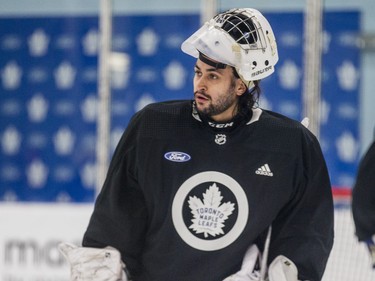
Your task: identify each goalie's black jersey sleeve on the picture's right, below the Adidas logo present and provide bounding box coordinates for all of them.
[269,128,333,281]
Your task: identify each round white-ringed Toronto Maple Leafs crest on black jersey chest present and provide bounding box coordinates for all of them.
[171,171,249,251]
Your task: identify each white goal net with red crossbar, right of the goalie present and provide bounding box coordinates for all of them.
[322,188,375,281]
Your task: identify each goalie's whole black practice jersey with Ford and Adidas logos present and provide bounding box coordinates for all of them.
[83,101,333,281]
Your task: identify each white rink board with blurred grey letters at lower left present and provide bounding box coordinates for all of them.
[0,203,93,281]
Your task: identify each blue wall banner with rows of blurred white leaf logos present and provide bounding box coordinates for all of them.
[0,11,360,202]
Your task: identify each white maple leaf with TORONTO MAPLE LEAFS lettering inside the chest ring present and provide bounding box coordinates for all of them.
[188,183,235,238]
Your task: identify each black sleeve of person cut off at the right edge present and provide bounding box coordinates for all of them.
[352,141,375,241]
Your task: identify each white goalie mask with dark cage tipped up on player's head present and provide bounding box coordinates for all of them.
[181,8,278,82]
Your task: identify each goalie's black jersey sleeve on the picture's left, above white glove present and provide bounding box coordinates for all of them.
[82,110,147,274]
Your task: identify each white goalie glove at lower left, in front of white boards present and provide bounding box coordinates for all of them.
[58,243,130,281]
